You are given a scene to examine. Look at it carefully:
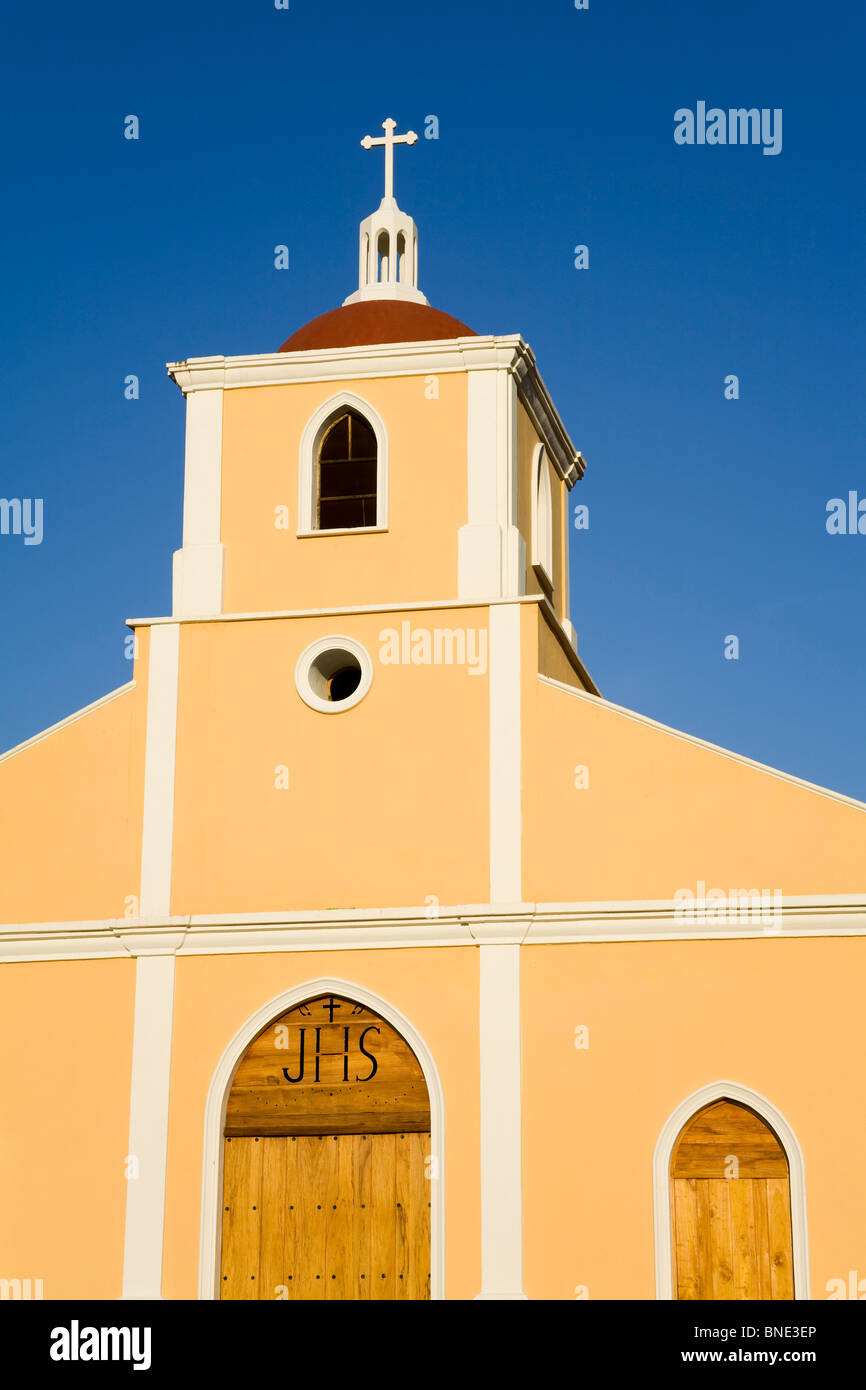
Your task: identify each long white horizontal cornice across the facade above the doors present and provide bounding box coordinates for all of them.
[0,885,866,962]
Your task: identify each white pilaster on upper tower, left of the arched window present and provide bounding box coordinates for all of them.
[172,388,224,617]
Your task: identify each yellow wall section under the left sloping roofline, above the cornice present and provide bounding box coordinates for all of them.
[0,647,149,922]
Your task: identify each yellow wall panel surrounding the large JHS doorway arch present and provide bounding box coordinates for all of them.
[163,947,481,1298]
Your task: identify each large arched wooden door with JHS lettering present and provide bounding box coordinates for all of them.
[220,995,430,1300]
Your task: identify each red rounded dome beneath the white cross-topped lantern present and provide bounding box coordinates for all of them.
[279,299,478,352]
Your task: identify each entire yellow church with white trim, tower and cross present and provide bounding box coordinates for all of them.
[0,121,866,1301]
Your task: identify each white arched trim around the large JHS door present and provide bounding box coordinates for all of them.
[199,976,445,1298]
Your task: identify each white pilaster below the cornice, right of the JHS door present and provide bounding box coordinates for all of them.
[477,942,525,1301]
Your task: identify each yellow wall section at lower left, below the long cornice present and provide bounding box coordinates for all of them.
[0,959,135,1298]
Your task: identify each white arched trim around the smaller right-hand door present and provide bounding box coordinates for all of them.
[652,1081,809,1300]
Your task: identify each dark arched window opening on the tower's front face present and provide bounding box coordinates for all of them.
[316,410,378,531]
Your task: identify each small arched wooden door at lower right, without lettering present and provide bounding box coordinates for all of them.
[670,1099,794,1300]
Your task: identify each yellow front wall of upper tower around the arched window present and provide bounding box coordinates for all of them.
[222,373,467,613]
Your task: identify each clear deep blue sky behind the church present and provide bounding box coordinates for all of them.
[0,0,866,799]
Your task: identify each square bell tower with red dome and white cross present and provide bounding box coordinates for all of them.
[168,117,591,688]
